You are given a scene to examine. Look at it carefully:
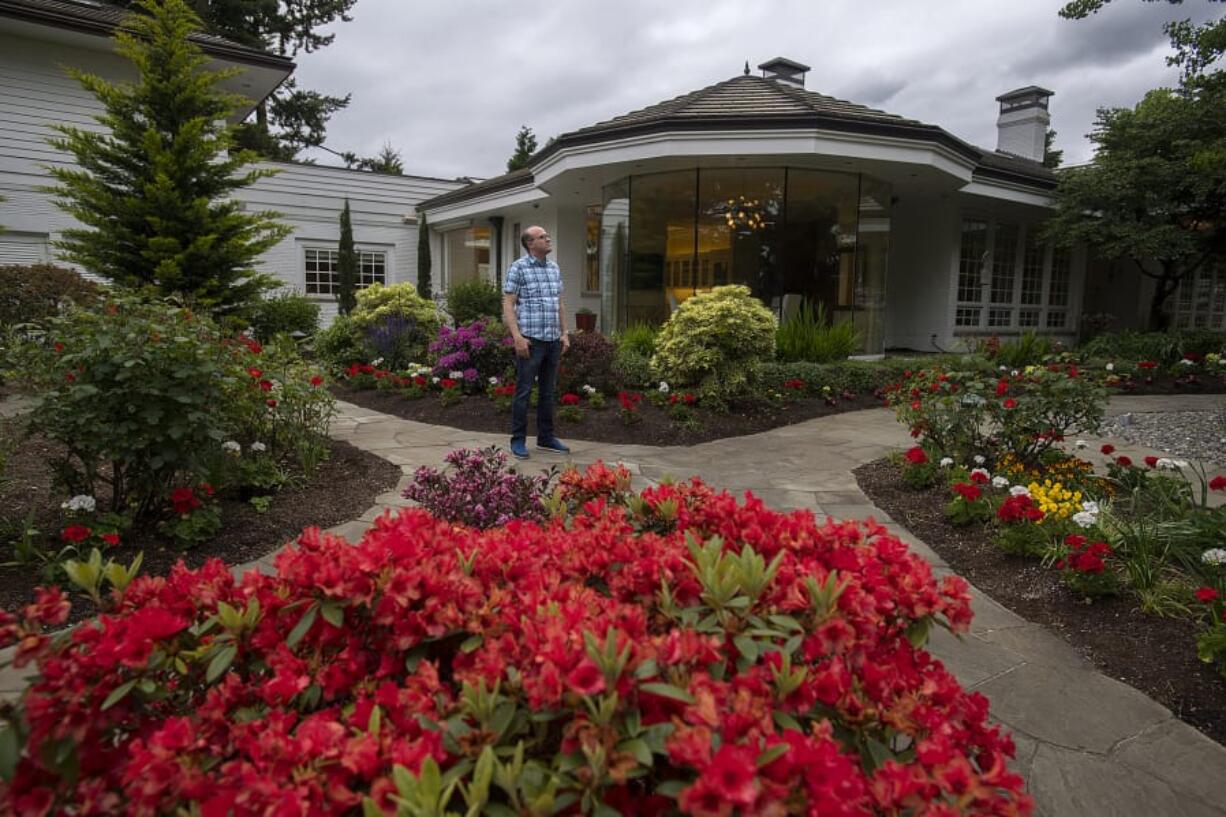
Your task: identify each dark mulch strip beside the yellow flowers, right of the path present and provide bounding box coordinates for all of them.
[855,460,1226,743]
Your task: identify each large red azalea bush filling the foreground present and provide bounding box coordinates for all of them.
[0,466,1032,817]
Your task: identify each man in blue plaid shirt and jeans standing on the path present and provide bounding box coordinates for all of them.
[503,226,570,460]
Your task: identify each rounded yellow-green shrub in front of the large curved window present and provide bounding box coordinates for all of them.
[651,285,776,402]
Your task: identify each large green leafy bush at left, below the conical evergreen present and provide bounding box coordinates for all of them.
[16,298,234,518]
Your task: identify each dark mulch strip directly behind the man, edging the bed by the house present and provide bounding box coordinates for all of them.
[333,388,881,445]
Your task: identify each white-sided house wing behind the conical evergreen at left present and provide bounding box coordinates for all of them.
[0,0,461,319]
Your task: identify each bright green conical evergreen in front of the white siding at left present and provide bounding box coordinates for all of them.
[48,0,289,312]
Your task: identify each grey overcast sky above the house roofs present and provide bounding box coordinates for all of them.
[297,0,1222,178]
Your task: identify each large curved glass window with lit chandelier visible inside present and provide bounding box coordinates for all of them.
[613,168,890,352]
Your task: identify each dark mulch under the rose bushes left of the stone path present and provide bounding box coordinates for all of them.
[0,420,401,621]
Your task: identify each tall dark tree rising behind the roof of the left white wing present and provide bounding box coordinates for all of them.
[113,0,357,161]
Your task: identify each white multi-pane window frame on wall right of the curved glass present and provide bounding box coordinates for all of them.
[950,213,1081,336]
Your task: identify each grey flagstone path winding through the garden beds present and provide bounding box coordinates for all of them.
[0,395,1226,817]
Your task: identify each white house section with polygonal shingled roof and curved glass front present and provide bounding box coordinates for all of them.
[419,59,1086,355]
